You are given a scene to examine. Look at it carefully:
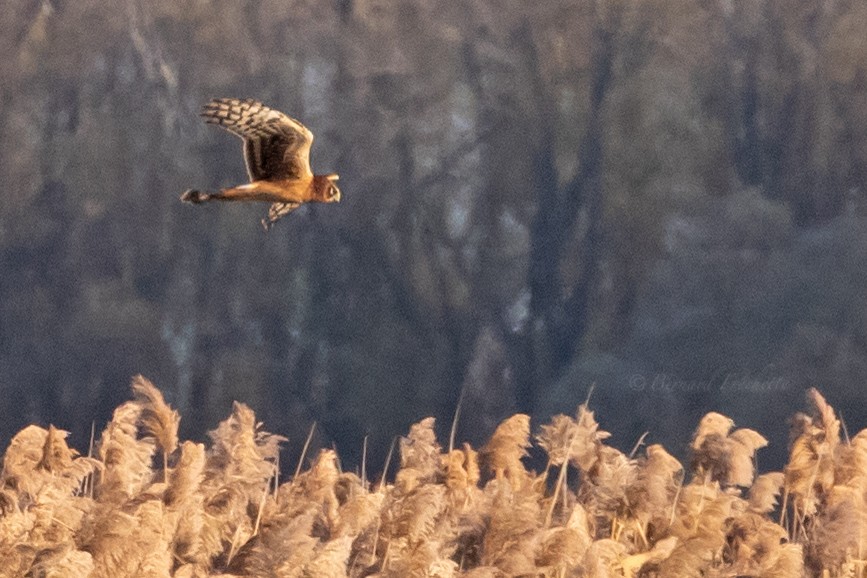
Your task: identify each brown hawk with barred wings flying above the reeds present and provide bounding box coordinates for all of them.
[181,98,340,230]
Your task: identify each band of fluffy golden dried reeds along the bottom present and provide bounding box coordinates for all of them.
[0,376,867,578]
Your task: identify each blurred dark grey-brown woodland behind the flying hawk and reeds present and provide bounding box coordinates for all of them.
[0,0,867,469]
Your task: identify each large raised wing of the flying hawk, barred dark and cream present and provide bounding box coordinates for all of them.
[202,98,313,181]
